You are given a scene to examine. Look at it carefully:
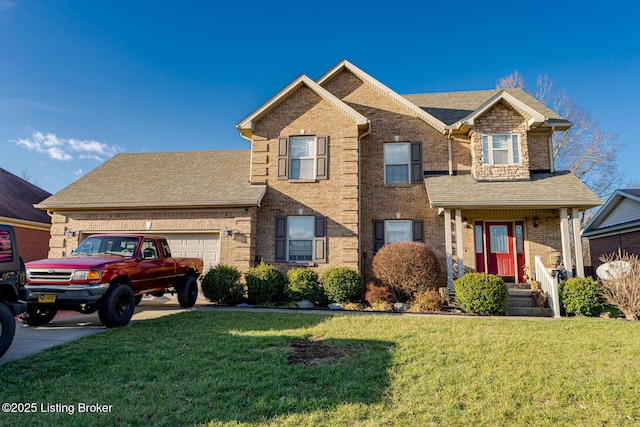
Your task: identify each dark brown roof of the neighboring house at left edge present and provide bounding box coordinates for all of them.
[0,168,51,224]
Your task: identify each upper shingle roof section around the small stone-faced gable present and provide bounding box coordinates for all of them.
[402,89,565,125]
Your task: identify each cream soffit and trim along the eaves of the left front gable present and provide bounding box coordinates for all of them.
[236,74,369,138]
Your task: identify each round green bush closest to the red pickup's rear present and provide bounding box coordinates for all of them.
[202,264,244,305]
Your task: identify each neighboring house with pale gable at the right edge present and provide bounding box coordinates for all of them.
[582,189,640,271]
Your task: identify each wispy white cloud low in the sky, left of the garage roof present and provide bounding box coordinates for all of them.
[17,131,122,162]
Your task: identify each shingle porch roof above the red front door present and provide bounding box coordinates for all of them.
[424,172,602,209]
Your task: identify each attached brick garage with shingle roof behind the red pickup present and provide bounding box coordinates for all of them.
[36,150,266,271]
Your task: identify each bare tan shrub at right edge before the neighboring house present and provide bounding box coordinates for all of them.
[600,251,640,320]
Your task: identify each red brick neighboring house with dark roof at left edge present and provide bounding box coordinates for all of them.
[0,168,51,262]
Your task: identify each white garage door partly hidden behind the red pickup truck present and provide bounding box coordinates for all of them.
[164,233,220,273]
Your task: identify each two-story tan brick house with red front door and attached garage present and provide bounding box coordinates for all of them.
[39,61,601,284]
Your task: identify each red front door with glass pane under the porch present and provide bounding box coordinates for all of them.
[486,222,515,281]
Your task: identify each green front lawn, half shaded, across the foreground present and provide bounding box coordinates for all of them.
[0,311,640,426]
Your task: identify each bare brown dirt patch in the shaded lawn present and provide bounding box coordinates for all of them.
[287,336,360,366]
